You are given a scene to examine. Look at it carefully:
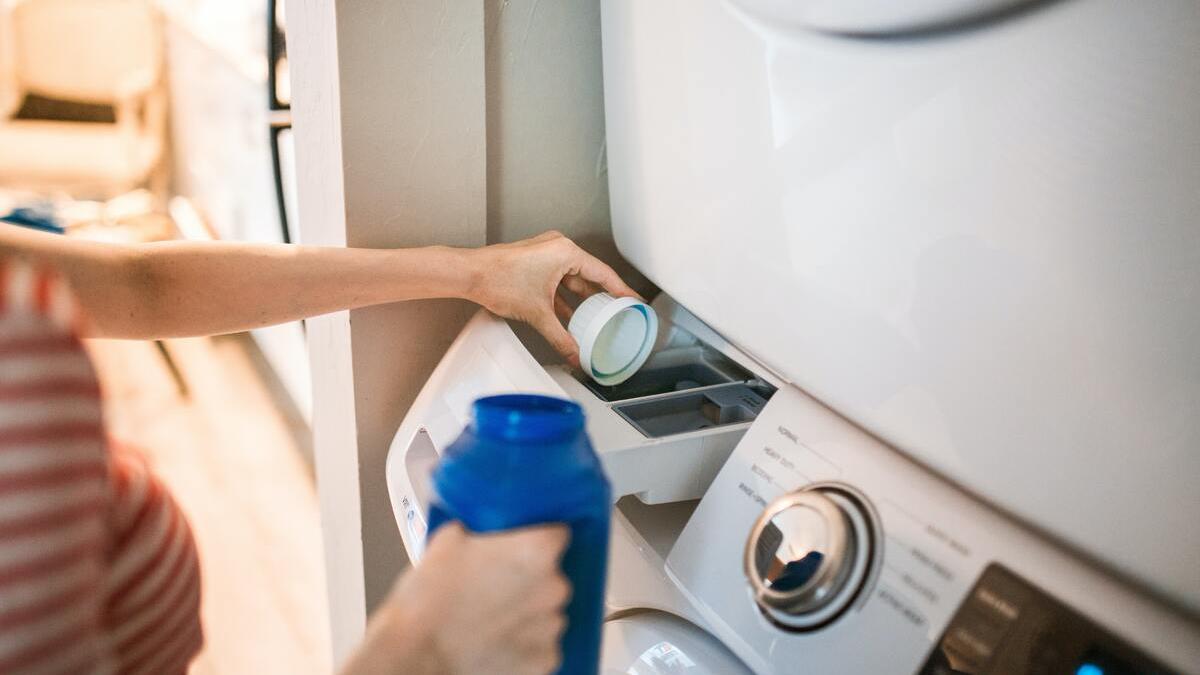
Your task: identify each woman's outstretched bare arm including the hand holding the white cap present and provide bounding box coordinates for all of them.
[0,226,634,359]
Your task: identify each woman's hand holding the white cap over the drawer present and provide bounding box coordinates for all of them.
[469,231,638,366]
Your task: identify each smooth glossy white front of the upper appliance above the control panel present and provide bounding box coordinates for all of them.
[602,0,1200,607]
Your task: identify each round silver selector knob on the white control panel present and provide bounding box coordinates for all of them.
[745,486,874,631]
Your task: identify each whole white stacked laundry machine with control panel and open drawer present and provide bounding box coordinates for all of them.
[388,0,1200,675]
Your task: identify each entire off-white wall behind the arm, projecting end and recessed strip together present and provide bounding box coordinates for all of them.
[287,0,648,658]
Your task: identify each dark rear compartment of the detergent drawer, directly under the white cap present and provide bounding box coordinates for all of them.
[578,345,754,402]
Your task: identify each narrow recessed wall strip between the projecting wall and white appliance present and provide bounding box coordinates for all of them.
[485,0,648,289]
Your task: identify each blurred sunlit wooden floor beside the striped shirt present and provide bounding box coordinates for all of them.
[89,335,330,675]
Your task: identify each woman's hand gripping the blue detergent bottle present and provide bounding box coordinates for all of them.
[342,522,571,675]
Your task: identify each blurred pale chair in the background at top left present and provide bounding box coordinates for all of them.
[0,0,167,199]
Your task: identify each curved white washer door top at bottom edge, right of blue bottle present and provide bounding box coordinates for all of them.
[600,611,752,675]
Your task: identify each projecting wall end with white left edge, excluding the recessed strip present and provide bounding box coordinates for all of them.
[287,0,486,661]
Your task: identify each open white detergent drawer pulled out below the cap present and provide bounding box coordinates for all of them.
[386,295,779,557]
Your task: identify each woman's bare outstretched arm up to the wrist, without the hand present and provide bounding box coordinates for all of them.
[0,222,472,338]
